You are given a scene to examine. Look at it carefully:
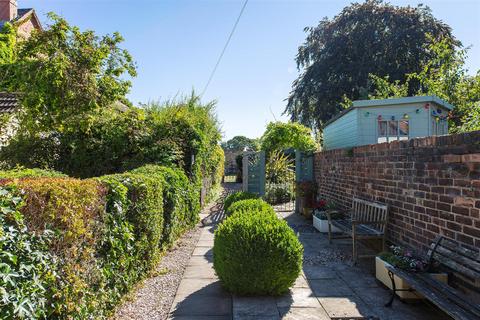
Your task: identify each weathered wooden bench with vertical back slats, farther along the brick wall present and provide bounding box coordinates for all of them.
[327,198,388,264]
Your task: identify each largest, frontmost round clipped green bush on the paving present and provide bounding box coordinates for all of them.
[213,211,303,295]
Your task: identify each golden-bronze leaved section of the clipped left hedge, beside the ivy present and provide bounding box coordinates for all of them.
[4,178,105,318]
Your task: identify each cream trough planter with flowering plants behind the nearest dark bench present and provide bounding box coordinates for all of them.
[375,246,448,300]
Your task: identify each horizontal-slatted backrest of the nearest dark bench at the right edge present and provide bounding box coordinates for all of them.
[427,236,480,288]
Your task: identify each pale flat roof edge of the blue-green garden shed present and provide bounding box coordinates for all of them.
[324,96,454,127]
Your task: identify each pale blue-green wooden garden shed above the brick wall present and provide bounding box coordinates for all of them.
[323,96,453,150]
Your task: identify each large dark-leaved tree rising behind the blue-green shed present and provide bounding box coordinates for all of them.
[285,0,460,129]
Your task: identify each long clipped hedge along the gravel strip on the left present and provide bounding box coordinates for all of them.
[0,166,200,319]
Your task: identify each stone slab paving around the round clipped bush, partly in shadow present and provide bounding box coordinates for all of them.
[170,185,448,320]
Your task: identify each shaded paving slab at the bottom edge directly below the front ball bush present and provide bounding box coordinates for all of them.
[233,296,279,319]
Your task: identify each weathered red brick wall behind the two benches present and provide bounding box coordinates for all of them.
[315,131,480,250]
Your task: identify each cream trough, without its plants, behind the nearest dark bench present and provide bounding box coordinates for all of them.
[375,257,448,300]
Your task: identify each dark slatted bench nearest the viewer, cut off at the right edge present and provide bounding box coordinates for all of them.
[385,236,480,320]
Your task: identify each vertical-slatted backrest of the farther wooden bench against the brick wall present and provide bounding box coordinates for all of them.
[352,198,388,232]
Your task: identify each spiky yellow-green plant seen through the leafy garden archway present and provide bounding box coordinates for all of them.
[265,150,295,183]
